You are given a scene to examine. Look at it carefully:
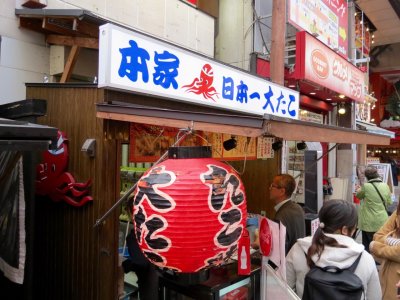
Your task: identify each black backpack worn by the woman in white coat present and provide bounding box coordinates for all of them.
[301,252,365,300]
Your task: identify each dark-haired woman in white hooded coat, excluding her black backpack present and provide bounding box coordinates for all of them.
[286,200,382,300]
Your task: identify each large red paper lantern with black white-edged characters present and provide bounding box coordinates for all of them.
[133,147,247,273]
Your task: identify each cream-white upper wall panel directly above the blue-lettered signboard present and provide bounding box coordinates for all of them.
[54,0,215,57]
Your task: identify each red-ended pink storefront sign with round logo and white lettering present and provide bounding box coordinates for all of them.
[295,31,365,102]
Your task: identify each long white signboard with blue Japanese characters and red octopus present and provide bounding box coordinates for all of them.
[98,24,299,119]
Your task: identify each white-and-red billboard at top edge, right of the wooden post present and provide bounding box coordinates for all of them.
[289,0,348,57]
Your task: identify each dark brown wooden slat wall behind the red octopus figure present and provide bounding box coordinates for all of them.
[27,85,128,300]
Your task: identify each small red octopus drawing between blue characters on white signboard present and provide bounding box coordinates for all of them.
[182,64,218,102]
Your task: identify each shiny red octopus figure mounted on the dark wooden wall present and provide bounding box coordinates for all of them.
[36,131,93,207]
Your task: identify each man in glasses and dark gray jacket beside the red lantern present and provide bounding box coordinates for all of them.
[269,174,306,254]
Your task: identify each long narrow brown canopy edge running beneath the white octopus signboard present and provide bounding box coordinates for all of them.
[97,102,390,145]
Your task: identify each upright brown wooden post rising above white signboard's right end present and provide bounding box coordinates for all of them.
[271,0,286,85]
